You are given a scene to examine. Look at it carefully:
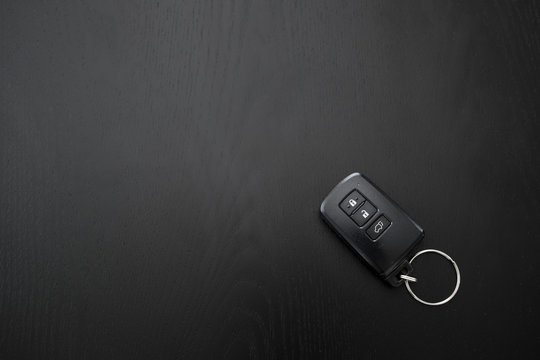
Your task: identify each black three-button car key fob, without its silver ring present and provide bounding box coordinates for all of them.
[321,173,424,286]
